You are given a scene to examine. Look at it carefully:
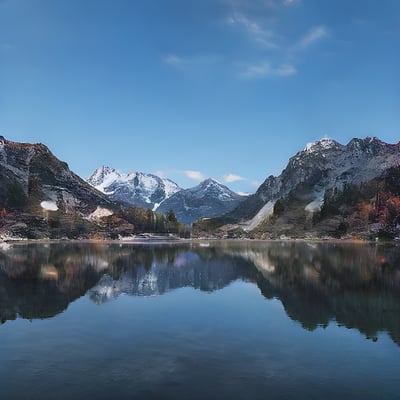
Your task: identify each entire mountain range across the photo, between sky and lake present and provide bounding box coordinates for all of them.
[0,137,400,238]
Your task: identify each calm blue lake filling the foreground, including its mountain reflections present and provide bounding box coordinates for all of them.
[0,241,400,400]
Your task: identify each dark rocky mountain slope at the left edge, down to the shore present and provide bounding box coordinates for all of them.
[0,137,122,238]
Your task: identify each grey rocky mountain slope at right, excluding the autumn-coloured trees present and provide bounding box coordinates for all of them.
[198,137,400,237]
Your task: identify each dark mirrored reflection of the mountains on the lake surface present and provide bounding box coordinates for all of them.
[0,242,400,345]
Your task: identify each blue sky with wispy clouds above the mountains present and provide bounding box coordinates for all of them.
[0,0,400,192]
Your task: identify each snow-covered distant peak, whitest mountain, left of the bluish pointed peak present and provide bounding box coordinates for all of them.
[87,166,181,210]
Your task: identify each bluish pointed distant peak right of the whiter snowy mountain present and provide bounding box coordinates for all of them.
[157,178,245,223]
